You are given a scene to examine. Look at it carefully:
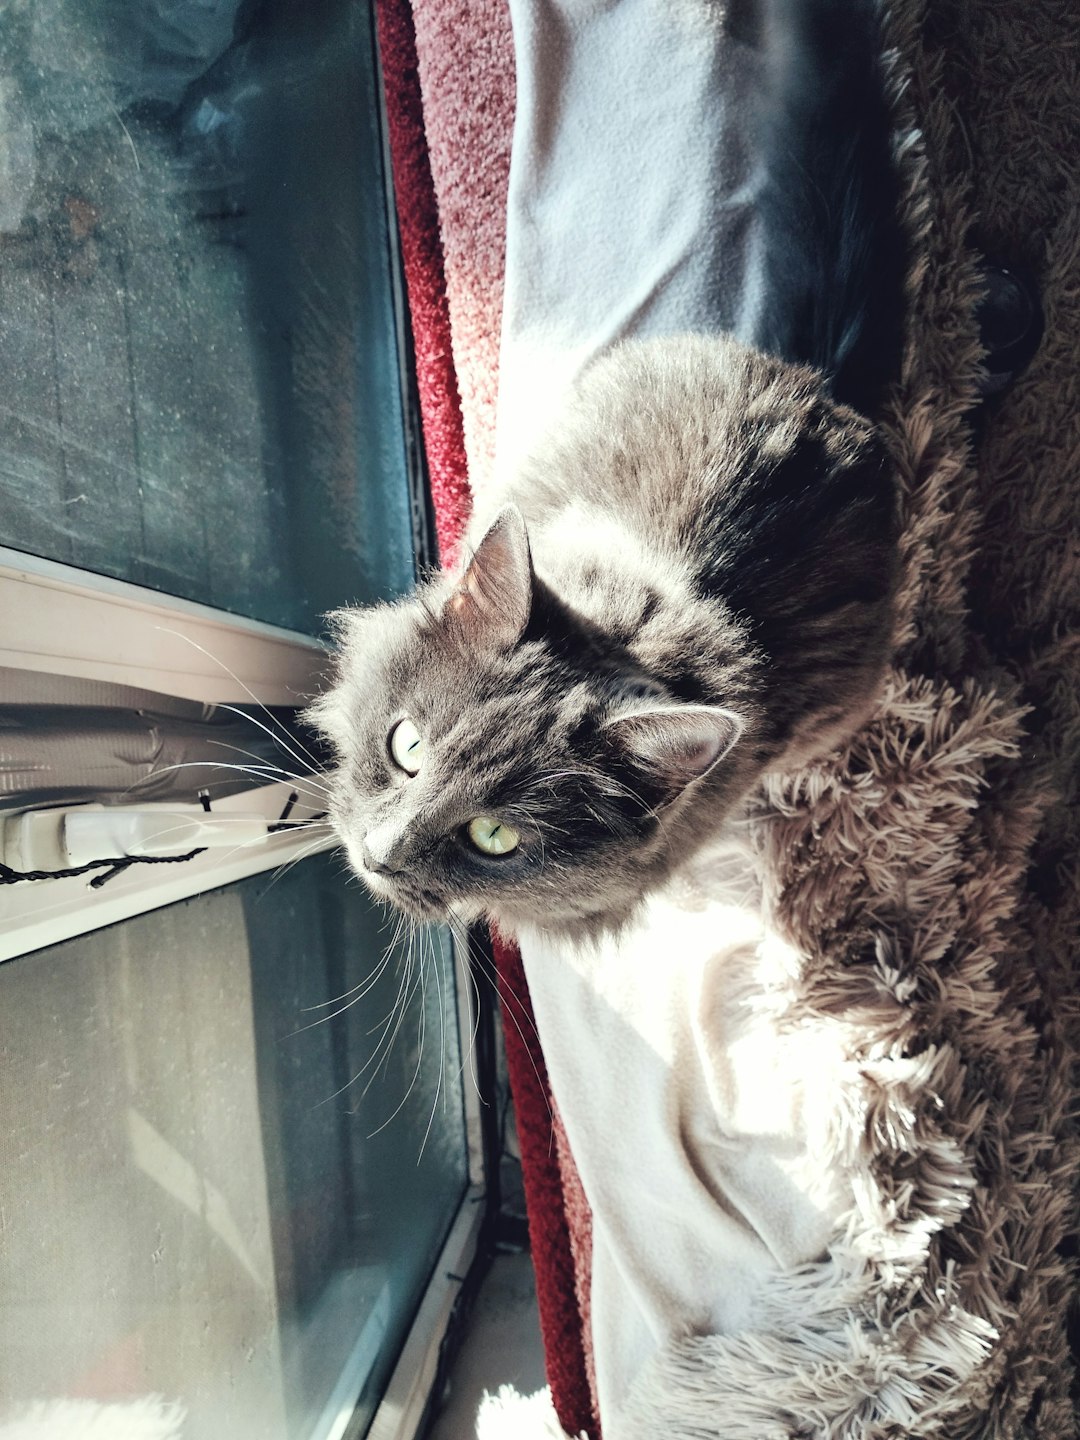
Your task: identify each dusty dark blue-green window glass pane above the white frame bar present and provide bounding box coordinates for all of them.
[0,0,412,632]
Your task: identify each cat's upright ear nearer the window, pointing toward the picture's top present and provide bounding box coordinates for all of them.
[446,505,533,649]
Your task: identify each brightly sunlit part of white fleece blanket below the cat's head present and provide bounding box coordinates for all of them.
[521,854,852,1440]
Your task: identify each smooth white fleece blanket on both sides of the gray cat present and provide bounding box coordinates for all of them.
[497,0,851,1440]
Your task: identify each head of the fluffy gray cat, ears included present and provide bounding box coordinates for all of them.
[308,508,742,927]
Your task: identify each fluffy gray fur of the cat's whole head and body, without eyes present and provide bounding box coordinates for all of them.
[310,337,894,935]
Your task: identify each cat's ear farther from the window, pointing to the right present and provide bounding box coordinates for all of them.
[605,704,743,795]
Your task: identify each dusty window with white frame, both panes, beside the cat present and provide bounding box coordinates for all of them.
[0,0,481,1440]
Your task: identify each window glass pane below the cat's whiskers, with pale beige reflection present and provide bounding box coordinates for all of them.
[0,857,467,1440]
